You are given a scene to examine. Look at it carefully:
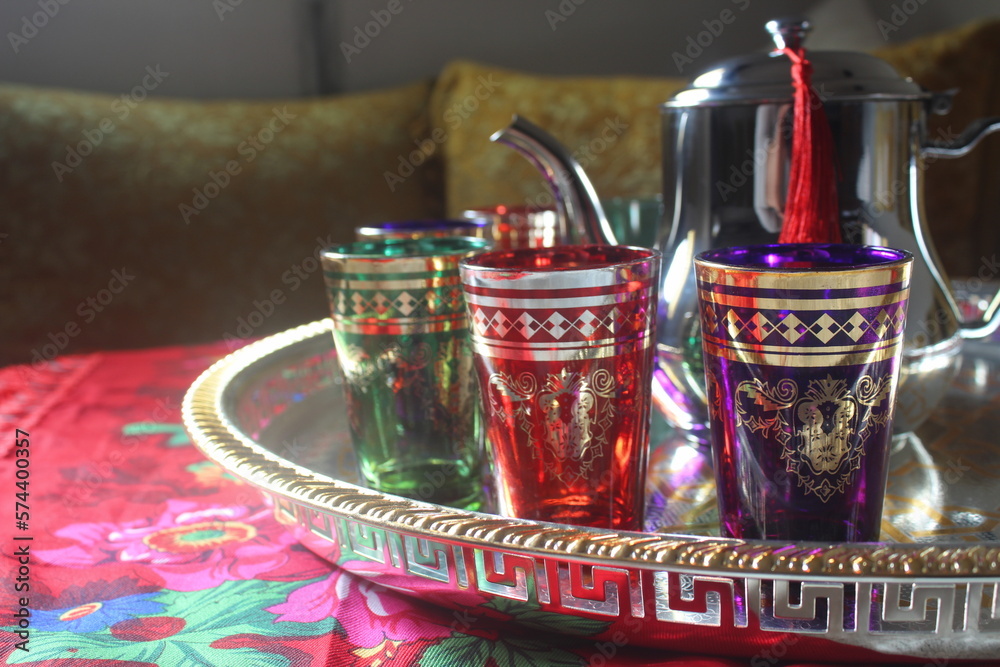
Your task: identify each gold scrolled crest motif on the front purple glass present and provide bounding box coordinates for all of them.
[736,375,892,502]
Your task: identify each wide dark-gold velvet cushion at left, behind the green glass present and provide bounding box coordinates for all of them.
[0,82,441,363]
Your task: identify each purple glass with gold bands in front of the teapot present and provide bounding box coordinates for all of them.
[695,244,913,542]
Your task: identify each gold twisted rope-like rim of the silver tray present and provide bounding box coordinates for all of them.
[181,318,1000,582]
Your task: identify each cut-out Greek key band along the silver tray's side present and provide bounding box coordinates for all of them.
[273,497,1000,639]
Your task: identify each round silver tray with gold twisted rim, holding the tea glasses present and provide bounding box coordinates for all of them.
[183,320,1000,660]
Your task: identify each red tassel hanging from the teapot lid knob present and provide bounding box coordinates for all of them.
[778,47,841,243]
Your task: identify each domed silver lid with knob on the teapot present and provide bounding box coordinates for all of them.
[664,19,930,107]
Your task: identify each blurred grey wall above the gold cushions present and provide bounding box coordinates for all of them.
[0,0,1000,98]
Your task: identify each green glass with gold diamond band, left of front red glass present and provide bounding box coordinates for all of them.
[323,237,489,510]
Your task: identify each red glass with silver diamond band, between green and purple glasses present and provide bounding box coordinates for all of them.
[460,246,660,530]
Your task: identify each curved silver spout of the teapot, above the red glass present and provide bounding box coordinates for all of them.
[490,115,618,245]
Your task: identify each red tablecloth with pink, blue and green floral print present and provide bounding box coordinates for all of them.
[0,344,996,667]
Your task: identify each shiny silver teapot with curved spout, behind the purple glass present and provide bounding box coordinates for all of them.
[493,20,1000,442]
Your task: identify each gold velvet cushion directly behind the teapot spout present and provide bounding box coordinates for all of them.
[429,61,686,215]
